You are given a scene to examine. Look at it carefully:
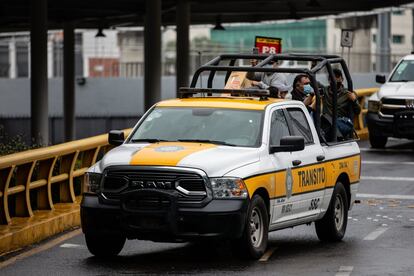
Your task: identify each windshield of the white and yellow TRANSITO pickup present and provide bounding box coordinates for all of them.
[129,107,263,147]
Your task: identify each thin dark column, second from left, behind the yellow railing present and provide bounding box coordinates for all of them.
[63,22,75,142]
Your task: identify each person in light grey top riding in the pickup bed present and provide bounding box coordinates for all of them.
[246,62,288,89]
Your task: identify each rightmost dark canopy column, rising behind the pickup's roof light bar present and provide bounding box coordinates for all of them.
[176,0,190,96]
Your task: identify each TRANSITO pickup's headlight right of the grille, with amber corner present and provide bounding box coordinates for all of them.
[210,177,248,199]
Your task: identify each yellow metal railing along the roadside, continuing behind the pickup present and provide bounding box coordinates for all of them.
[0,88,378,225]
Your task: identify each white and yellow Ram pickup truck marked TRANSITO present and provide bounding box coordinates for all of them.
[81,53,361,258]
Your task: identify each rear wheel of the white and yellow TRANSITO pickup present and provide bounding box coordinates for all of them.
[315,182,349,242]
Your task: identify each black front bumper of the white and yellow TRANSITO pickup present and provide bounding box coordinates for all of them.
[81,194,249,241]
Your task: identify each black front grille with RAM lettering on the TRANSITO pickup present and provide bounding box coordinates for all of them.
[102,168,207,202]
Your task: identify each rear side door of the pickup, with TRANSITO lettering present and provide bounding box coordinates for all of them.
[285,107,327,218]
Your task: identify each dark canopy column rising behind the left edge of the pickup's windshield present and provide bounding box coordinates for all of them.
[144,0,161,111]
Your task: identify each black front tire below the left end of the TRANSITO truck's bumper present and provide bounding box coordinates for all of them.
[85,233,126,257]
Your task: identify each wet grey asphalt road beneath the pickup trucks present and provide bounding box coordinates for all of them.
[0,140,414,276]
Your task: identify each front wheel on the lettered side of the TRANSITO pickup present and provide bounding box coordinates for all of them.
[232,195,269,260]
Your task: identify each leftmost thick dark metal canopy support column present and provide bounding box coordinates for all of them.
[30,0,49,145]
